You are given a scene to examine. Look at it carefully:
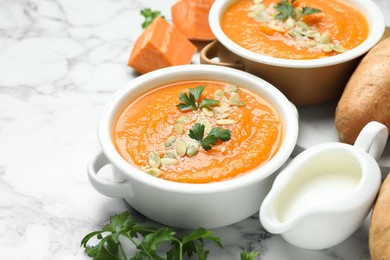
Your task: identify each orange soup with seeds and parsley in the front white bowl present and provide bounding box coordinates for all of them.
[113,81,283,183]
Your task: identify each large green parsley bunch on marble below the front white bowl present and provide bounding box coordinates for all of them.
[81,211,222,260]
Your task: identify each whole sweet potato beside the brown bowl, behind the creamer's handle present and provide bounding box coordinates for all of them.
[335,37,390,144]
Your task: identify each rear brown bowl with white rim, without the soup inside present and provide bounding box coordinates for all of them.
[200,0,385,106]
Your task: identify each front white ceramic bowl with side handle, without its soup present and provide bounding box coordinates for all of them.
[88,65,298,228]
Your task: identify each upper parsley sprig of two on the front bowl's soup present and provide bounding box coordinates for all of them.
[177,86,218,111]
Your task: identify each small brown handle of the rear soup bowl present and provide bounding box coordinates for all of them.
[199,40,244,70]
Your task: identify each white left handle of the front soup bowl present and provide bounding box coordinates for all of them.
[88,151,132,198]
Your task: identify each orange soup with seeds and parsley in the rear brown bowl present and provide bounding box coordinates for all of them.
[221,0,369,59]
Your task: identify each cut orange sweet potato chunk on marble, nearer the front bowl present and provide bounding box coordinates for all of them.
[128,16,197,74]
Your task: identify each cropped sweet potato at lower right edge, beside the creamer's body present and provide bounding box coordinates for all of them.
[368,173,390,260]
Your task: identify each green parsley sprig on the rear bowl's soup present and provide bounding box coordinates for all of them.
[275,0,321,21]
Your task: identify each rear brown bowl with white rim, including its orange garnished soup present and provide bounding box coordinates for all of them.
[201,0,385,106]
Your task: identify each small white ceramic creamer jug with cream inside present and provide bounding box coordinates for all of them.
[259,122,388,249]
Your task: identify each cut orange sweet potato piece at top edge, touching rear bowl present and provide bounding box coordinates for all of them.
[171,0,215,40]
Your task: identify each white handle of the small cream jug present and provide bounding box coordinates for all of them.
[354,121,388,160]
